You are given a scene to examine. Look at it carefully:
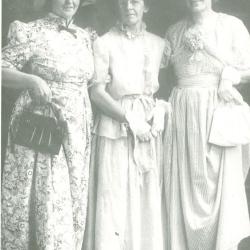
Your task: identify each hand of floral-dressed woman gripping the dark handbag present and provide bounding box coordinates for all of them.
[29,75,52,105]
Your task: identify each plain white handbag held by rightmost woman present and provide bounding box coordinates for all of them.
[208,103,250,147]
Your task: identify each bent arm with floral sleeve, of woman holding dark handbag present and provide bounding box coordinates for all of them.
[2,21,51,103]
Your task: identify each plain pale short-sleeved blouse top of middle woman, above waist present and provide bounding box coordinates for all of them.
[94,27,165,99]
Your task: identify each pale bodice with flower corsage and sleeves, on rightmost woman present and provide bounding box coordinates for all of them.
[163,13,250,82]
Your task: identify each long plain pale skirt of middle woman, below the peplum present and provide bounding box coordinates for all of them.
[83,135,163,250]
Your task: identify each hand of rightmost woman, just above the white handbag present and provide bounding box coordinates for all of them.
[218,79,243,104]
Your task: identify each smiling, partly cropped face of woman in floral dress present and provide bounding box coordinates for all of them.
[52,0,80,19]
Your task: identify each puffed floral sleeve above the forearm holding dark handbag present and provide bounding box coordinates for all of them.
[2,21,32,70]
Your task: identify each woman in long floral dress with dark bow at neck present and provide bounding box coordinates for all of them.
[2,0,94,250]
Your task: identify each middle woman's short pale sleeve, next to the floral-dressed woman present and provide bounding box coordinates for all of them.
[93,37,110,85]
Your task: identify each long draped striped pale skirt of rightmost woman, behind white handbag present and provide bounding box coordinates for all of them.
[164,86,250,250]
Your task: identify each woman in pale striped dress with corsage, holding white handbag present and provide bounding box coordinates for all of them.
[164,0,250,250]
